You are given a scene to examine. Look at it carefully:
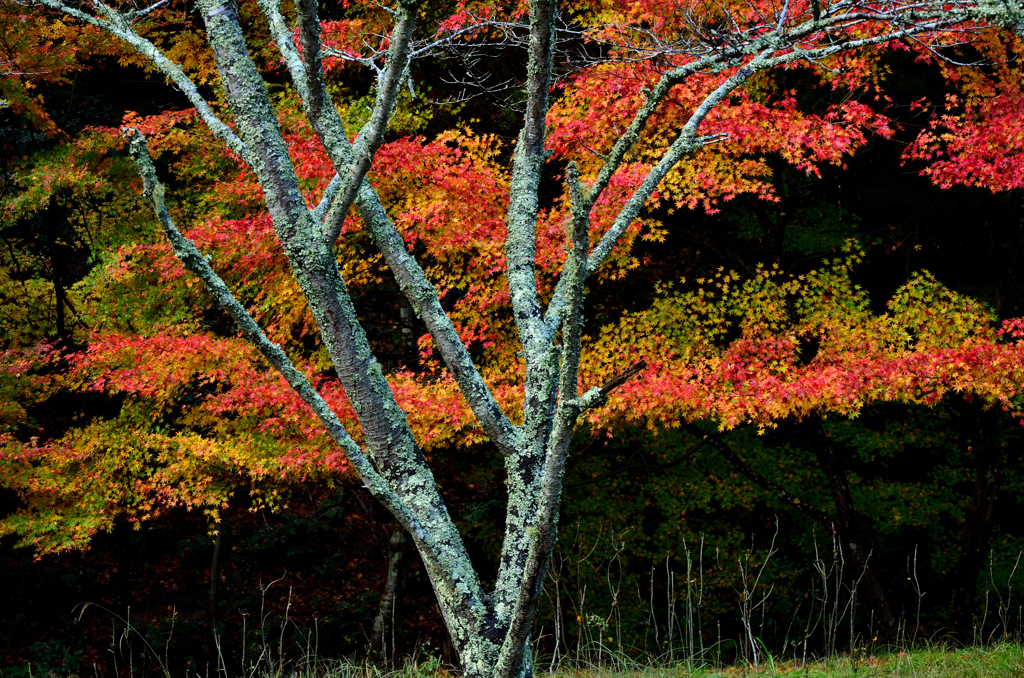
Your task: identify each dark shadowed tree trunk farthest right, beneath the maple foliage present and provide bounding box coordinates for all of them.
[949,411,1007,642]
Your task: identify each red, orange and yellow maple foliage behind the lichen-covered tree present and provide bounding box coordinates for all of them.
[3,3,1022,551]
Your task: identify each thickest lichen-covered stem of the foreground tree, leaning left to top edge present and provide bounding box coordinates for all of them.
[194,0,495,647]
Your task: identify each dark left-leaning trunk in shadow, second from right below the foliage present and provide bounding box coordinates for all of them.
[814,428,899,642]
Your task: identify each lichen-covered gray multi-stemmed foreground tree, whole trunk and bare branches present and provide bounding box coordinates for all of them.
[29,0,1022,678]
